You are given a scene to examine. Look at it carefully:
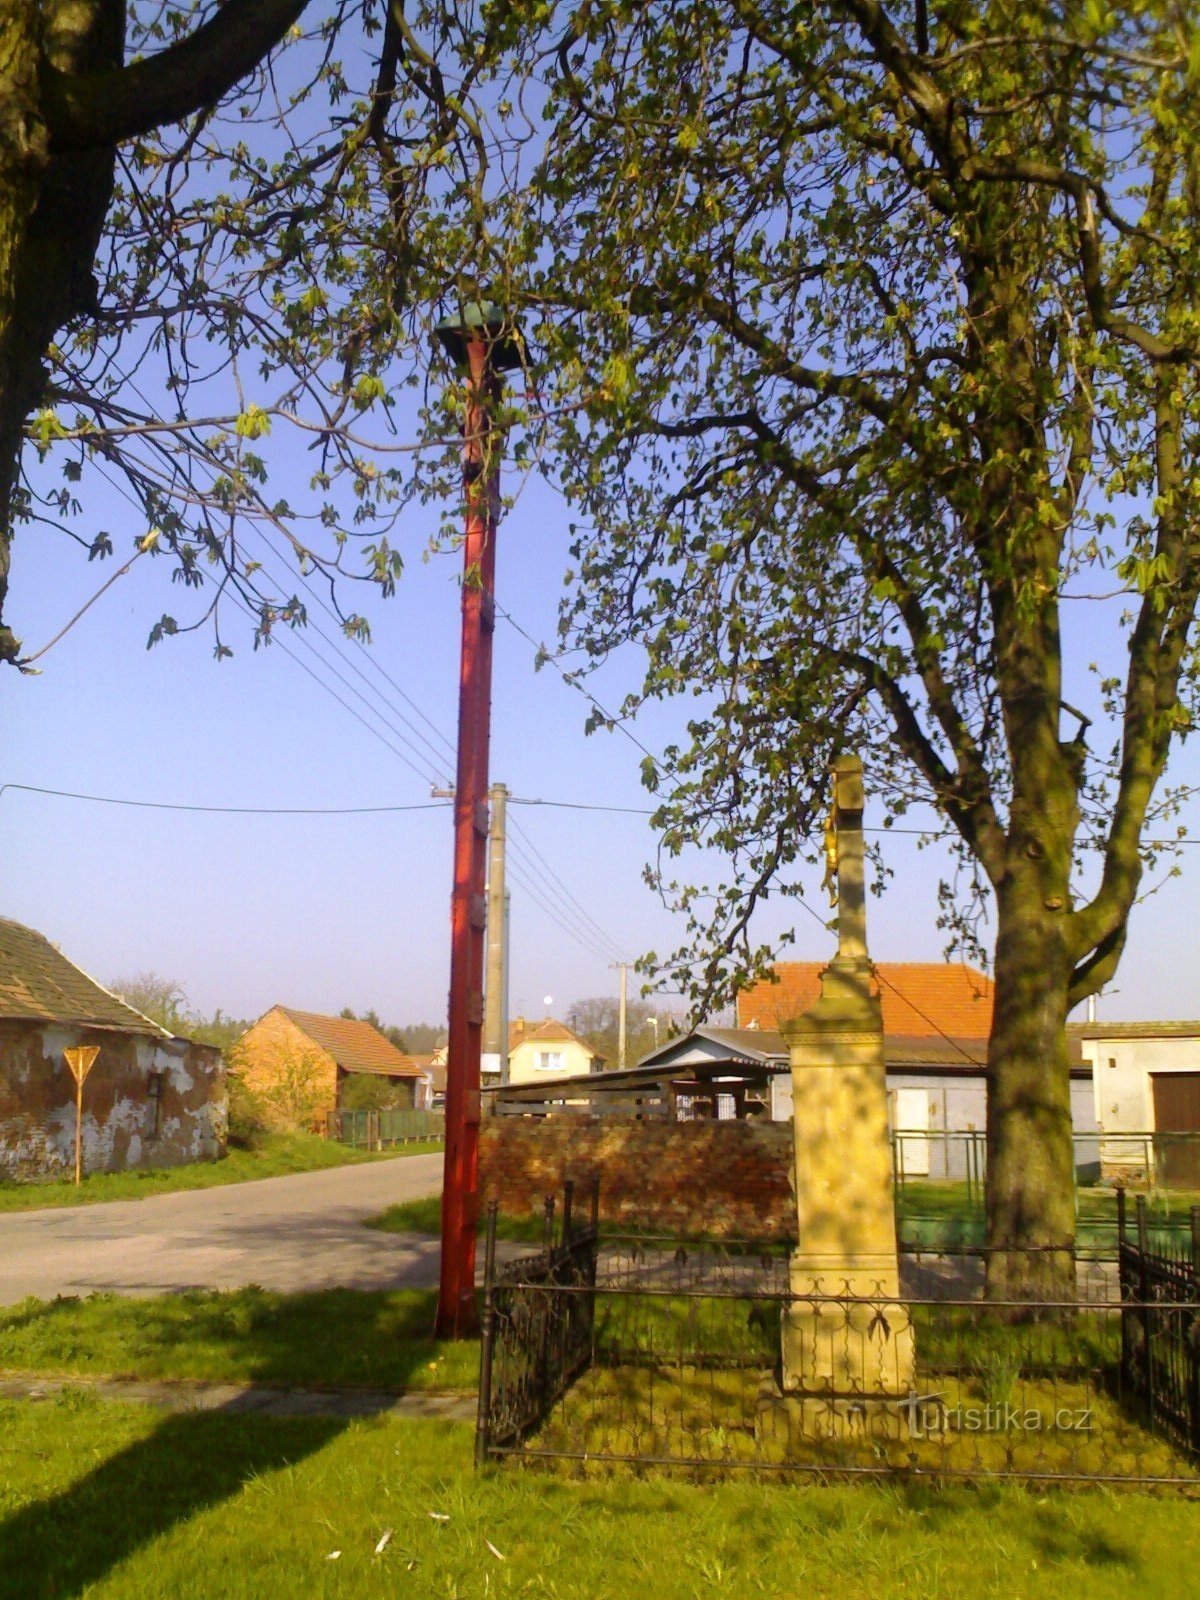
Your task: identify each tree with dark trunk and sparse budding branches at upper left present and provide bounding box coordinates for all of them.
[0,0,507,669]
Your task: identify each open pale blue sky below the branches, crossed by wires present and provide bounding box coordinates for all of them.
[0,425,1200,1022]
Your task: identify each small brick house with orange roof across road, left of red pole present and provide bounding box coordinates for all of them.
[235,1005,426,1128]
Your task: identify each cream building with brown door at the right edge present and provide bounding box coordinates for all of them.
[1067,1021,1200,1189]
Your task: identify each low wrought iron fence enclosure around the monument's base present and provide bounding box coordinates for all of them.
[477,1235,1200,1493]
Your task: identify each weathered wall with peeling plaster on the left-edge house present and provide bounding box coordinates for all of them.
[0,1022,226,1179]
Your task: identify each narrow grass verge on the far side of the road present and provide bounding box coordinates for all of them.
[0,1133,442,1211]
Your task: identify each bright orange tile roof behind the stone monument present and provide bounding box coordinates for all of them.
[738,962,994,1040]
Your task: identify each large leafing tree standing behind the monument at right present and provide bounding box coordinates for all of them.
[476,0,1200,1296]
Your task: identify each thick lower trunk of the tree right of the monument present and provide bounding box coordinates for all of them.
[987,864,1075,1301]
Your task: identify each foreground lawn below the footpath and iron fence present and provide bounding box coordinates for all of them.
[0,1395,1200,1600]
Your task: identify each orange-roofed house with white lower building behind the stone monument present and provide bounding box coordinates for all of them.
[638,962,1099,1178]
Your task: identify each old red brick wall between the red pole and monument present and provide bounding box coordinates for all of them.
[478,1117,795,1238]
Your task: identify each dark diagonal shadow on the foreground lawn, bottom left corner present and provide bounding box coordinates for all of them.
[0,1408,347,1600]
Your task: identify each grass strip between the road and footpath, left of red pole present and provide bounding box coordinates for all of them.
[0,1288,478,1395]
